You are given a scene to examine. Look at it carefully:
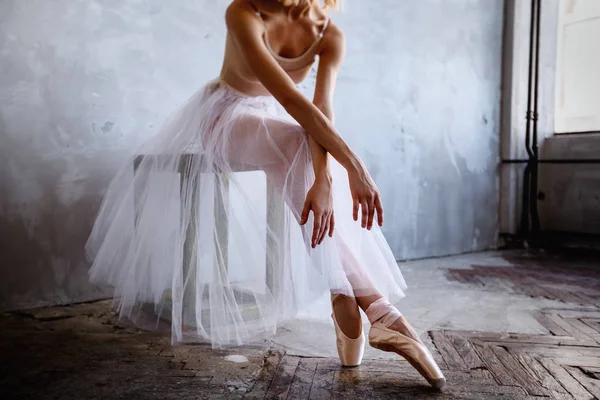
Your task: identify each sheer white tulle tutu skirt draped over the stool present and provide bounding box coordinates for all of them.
[86,80,406,347]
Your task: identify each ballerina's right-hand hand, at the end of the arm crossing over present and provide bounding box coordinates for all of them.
[348,163,383,230]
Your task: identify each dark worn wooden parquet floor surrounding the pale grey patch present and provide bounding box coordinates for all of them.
[0,253,600,400]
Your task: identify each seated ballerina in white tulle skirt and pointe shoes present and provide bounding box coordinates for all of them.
[86,0,445,388]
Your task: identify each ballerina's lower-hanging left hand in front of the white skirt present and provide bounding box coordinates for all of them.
[300,182,335,248]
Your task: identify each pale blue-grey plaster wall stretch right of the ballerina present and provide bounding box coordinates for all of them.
[336,0,504,259]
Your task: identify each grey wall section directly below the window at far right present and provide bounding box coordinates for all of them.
[539,134,600,234]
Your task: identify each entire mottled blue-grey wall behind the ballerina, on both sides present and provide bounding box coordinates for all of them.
[0,0,503,309]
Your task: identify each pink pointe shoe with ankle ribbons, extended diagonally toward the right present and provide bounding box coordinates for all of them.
[366,298,446,389]
